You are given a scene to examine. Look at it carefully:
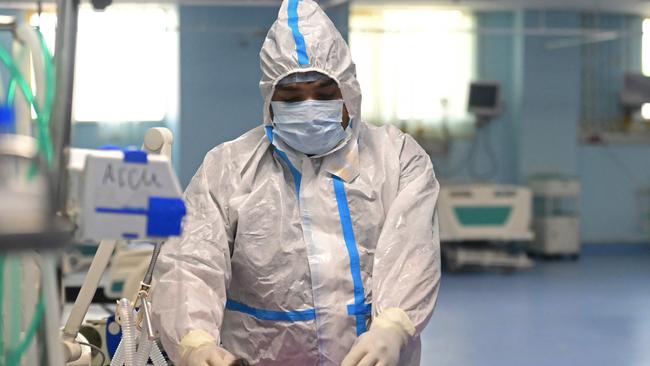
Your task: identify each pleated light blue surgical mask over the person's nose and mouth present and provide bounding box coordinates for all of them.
[271,99,347,155]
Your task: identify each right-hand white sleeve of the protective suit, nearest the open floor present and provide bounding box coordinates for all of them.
[372,136,440,335]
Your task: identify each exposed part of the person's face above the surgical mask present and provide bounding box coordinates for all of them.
[271,79,350,128]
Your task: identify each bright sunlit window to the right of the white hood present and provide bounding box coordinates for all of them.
[350,6,474,134]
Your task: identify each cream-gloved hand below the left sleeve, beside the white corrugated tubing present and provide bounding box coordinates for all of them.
[181,330,235,366]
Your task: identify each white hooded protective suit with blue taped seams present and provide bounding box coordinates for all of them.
[153,0,440,366]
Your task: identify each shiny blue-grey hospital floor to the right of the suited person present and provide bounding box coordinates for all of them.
[422,245,650,366]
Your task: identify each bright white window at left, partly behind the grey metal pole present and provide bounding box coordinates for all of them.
[31,5,178,122]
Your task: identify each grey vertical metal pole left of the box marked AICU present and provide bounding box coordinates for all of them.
[52,0,79,212]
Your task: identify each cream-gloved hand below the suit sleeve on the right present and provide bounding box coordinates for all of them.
[341,308,415,366]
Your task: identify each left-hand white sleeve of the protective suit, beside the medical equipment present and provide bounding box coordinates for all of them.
[152,155,234,363]
